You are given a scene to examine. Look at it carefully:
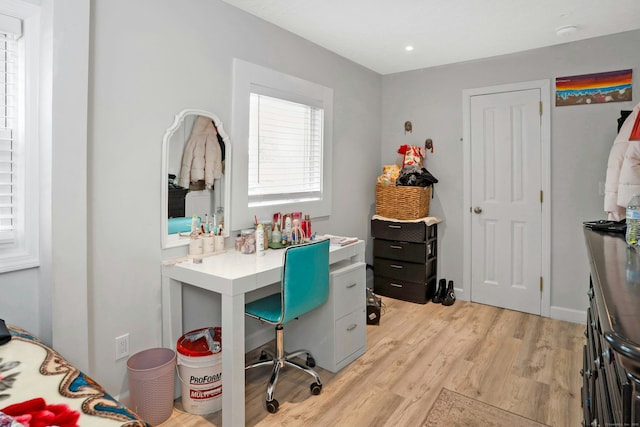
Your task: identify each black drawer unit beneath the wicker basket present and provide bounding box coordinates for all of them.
[371,219,438,304]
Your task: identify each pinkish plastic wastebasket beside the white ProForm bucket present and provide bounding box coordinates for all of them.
[127,348,176,425]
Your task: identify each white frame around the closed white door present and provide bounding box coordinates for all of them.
[460,80,551,317]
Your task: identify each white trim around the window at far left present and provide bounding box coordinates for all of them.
[0,0,40,273]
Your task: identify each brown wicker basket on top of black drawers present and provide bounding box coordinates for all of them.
[376,182,431,219]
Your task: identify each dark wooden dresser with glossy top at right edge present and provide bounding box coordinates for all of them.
[581,228,640,426]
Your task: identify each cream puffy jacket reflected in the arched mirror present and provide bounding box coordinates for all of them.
[178,116,222,188]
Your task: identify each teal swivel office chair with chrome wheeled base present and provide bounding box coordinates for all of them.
[245,240,329,414]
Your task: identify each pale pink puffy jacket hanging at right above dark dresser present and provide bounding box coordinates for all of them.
[604,104,640,221]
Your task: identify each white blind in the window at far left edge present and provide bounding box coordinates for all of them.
[0,23,18,245]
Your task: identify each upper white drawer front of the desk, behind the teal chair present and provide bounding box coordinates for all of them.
[331,262,367,319]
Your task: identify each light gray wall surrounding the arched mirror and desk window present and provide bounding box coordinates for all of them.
[88,0,381,394]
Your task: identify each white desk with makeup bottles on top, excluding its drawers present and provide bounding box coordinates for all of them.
[162,241,365,426]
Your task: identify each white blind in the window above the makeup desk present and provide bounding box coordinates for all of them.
[248,93,324,206]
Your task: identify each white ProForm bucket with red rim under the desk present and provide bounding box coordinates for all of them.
[176,328,222,415]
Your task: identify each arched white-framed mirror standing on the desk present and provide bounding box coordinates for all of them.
[160,109,231,248]
